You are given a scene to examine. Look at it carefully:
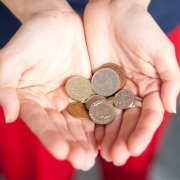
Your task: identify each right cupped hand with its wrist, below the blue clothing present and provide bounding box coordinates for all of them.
[84,0,180,165]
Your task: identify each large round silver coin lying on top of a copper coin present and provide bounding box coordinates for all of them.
[91,68,120,96]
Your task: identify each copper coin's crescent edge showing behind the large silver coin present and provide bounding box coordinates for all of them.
[101,63,126,89]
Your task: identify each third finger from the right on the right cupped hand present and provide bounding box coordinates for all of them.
[101,109,123,162]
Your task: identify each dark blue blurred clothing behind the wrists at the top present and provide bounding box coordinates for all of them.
[0,0,180,48]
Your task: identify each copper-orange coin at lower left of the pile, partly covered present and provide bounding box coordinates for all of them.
[67,102,90,119]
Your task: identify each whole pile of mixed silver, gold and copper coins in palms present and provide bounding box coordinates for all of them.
[65,63,142,124]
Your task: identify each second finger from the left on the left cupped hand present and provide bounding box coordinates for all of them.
[47,109,86,169]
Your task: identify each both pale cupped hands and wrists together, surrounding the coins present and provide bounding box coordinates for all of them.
[0,0,180,170]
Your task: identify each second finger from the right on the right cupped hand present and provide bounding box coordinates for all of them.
[111,108,141,166]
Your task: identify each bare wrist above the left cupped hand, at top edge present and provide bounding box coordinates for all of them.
[2,0,73,22]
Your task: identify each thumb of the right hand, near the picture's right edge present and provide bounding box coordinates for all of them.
[155,44,180,113]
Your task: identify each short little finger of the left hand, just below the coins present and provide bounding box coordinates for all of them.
[82,119,98,157]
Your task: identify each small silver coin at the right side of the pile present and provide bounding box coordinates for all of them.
[114,89,135,109]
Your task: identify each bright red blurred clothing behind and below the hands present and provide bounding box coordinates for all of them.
[0,27,180,180]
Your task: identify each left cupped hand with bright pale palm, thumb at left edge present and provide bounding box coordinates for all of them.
[0,7,97,170]
